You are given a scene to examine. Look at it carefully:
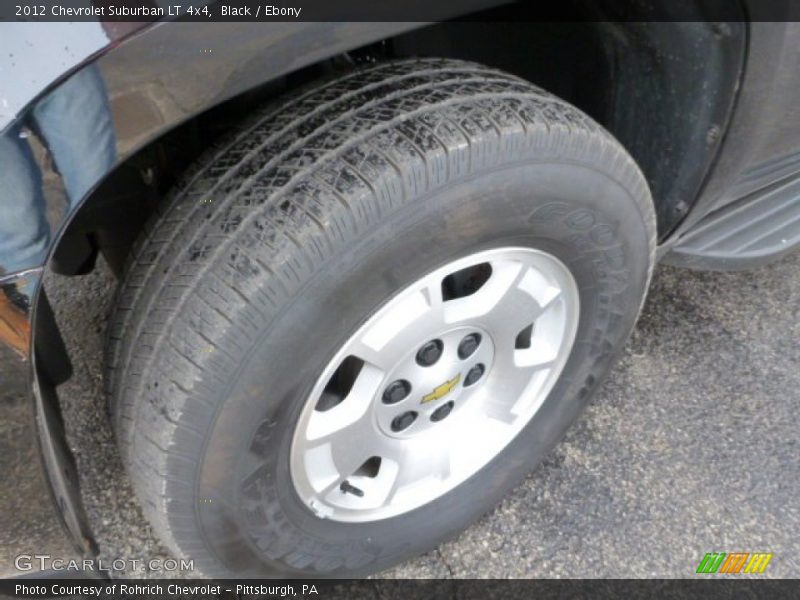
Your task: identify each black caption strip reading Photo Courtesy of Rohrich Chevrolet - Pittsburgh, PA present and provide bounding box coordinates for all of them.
[0,576,800,600]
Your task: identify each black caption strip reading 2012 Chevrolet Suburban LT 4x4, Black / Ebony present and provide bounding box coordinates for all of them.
[0,0,800,23]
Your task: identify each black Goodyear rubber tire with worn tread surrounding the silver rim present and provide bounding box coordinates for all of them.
[107,60,656,577]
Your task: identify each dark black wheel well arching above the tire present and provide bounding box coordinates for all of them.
[52,3,747,274]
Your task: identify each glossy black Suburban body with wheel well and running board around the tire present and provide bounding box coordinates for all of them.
[0,0,800,576]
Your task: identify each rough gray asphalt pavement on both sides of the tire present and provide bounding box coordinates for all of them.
[48,254,800,578]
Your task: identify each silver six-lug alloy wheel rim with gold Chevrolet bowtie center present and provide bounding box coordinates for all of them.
[290,247,579,522]
